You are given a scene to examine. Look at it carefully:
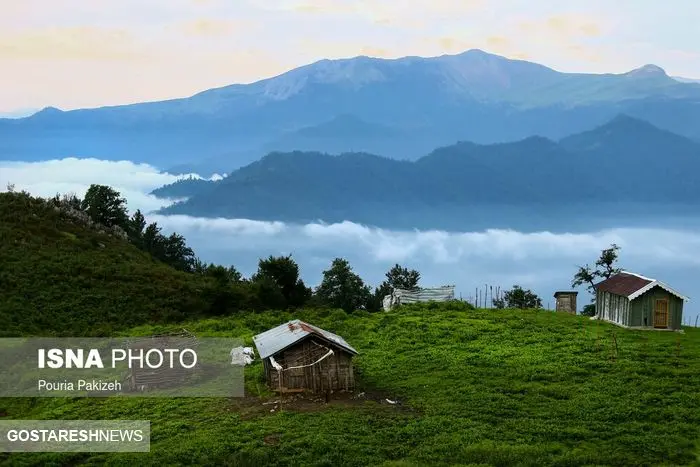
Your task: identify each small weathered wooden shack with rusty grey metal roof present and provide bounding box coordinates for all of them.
[253,320,357,394]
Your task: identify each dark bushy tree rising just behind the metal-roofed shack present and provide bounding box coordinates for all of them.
[251,255,311,308]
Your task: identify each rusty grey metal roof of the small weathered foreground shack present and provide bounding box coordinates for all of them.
[253,319,357,358]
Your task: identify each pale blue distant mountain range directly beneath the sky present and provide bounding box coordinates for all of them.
[0,50,700,175]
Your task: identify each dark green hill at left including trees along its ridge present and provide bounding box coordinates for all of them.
[0,191,328,336]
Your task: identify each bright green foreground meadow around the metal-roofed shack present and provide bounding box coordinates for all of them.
[0,305,700,466]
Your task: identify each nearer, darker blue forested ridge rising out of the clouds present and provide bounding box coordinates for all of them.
[153,115,700,230]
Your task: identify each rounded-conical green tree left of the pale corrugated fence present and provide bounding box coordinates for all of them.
[316,258,371,313]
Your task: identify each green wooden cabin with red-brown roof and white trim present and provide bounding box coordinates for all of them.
[595,271,688,330]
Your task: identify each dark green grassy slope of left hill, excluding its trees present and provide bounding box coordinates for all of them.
[0,193,213,336]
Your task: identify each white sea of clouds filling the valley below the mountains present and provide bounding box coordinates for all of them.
[0,158,700,320]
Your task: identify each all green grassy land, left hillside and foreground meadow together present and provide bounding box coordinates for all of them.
[0,193,700,466]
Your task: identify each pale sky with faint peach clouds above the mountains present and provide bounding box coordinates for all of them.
[0,0,700,112]
